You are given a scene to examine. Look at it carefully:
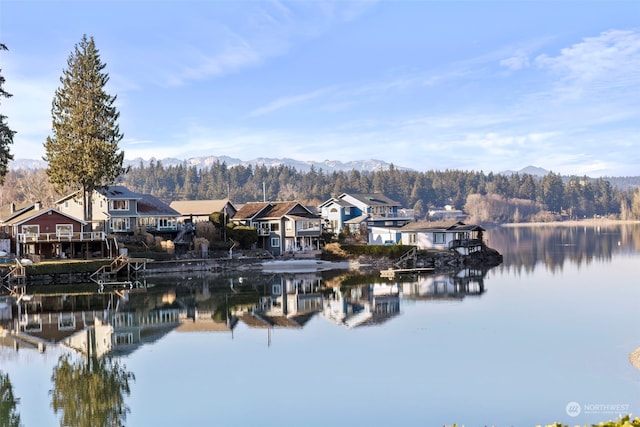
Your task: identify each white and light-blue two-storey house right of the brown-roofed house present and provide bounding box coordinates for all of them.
[318,193,414,235]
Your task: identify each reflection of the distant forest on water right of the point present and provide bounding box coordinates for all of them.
[487,223,640,274]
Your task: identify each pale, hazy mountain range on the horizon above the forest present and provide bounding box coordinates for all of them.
[125,156,411,173]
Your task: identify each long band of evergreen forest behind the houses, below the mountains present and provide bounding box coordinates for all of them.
[5,161,640,226]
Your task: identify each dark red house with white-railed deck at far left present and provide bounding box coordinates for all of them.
[1,203,110,260]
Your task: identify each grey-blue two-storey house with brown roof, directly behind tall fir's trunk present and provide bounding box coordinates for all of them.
[55,185,180,234]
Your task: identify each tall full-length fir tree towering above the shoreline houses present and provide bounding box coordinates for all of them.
[44,35,126,221]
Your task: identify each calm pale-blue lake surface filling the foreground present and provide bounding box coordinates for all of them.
[0,225,640,427]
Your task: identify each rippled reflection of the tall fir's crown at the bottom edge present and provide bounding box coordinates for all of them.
[50,354,135,427]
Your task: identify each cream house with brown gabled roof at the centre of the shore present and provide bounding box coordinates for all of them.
[231,201,322,256]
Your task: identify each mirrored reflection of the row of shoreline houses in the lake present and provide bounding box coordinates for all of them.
[5,269,486,360]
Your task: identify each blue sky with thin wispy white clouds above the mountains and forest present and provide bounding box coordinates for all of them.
[0,0,640,176]
